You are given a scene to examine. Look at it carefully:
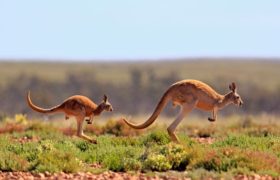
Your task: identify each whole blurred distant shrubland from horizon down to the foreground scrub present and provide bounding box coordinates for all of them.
[0,59,280,116]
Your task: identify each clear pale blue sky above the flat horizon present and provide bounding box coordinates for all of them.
[0,0,280,60]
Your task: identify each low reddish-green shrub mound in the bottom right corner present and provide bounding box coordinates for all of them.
[190,147,280,176]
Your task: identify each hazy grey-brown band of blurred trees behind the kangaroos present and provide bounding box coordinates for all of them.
[0,69,280,115]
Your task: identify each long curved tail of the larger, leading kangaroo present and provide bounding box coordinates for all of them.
[123,90,172,129]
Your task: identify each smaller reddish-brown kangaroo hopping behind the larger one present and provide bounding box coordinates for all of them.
[27,91,113,144]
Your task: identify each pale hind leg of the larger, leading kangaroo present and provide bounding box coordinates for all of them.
[167,102,195,143]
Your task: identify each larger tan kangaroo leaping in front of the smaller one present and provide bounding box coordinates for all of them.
[123,79,243,143]
